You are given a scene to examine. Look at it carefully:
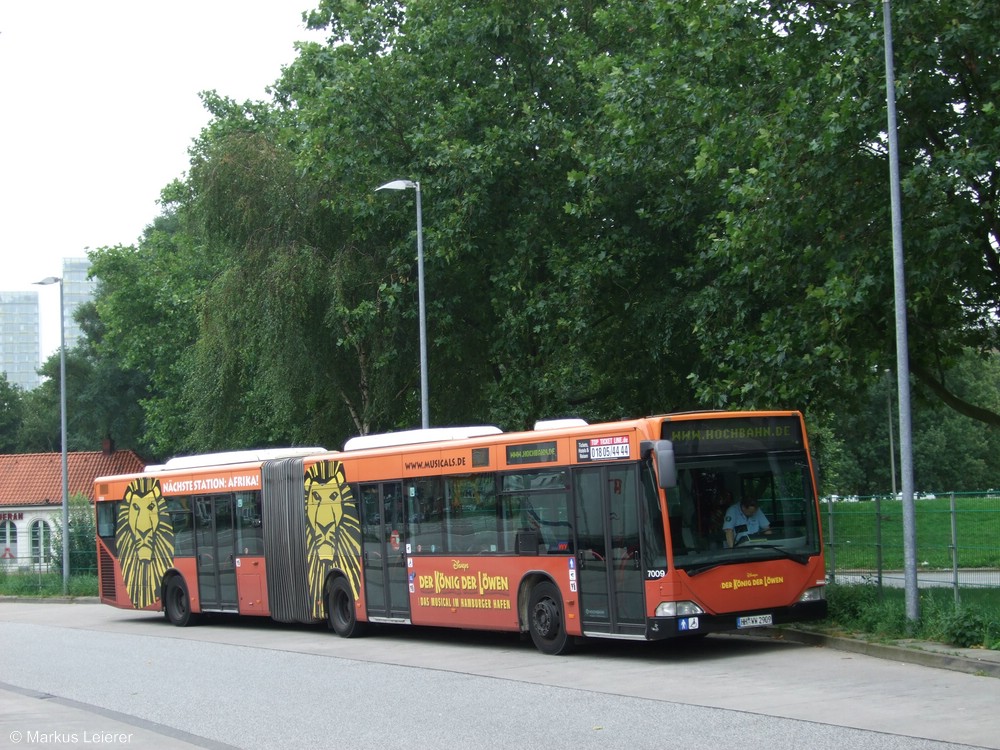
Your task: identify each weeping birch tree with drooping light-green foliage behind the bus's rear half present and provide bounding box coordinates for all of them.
[184,93,416,445]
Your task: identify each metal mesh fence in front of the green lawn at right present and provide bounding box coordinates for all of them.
[821,490,1000,600]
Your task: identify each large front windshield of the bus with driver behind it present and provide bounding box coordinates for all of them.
[667,452,820,573]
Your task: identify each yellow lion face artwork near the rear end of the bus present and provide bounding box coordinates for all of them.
[115,477,174,609]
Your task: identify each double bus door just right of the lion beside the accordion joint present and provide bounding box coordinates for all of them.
[360,482,410,620]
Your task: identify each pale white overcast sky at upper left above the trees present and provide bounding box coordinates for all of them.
[0,0,322,360]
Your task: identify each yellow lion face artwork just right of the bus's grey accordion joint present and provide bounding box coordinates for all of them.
[305,461,361,619]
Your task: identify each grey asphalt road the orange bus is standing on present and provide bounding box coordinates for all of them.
[0,602,1000,750]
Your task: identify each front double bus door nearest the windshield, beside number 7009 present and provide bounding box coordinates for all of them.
[573,466,645,635]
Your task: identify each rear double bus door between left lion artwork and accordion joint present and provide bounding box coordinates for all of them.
[194,495,239,612]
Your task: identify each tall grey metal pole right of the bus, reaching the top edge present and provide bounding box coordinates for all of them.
[882,0,920,624]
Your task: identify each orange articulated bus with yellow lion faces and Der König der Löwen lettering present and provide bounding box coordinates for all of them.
[95,411,826,654]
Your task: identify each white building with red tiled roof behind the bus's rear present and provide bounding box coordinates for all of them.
[0,447,146,569]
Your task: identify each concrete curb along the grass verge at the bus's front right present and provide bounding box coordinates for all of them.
[765,628,1000,678]
